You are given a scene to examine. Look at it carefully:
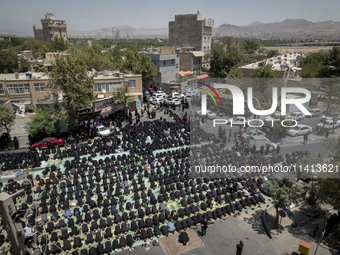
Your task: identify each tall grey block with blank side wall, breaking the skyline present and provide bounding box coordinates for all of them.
[169,12,214,68]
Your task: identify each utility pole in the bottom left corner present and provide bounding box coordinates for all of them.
[0,190,27,255]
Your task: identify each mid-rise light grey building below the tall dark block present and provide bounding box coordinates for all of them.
[144,47,179,89]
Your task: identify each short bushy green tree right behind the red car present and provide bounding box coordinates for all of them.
[26,107,59,139]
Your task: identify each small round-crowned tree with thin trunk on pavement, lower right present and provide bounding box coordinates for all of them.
[268,177,302,226]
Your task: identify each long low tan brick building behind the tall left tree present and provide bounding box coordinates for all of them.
[0,71,143,112]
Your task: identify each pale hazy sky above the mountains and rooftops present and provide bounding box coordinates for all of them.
[0,0,340,35]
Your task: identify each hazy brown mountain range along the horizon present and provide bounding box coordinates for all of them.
[11,19,340,41]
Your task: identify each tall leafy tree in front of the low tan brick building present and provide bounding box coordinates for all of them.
[48,55,94,130]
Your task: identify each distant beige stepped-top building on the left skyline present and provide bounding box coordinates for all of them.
[33,13,68,42]
